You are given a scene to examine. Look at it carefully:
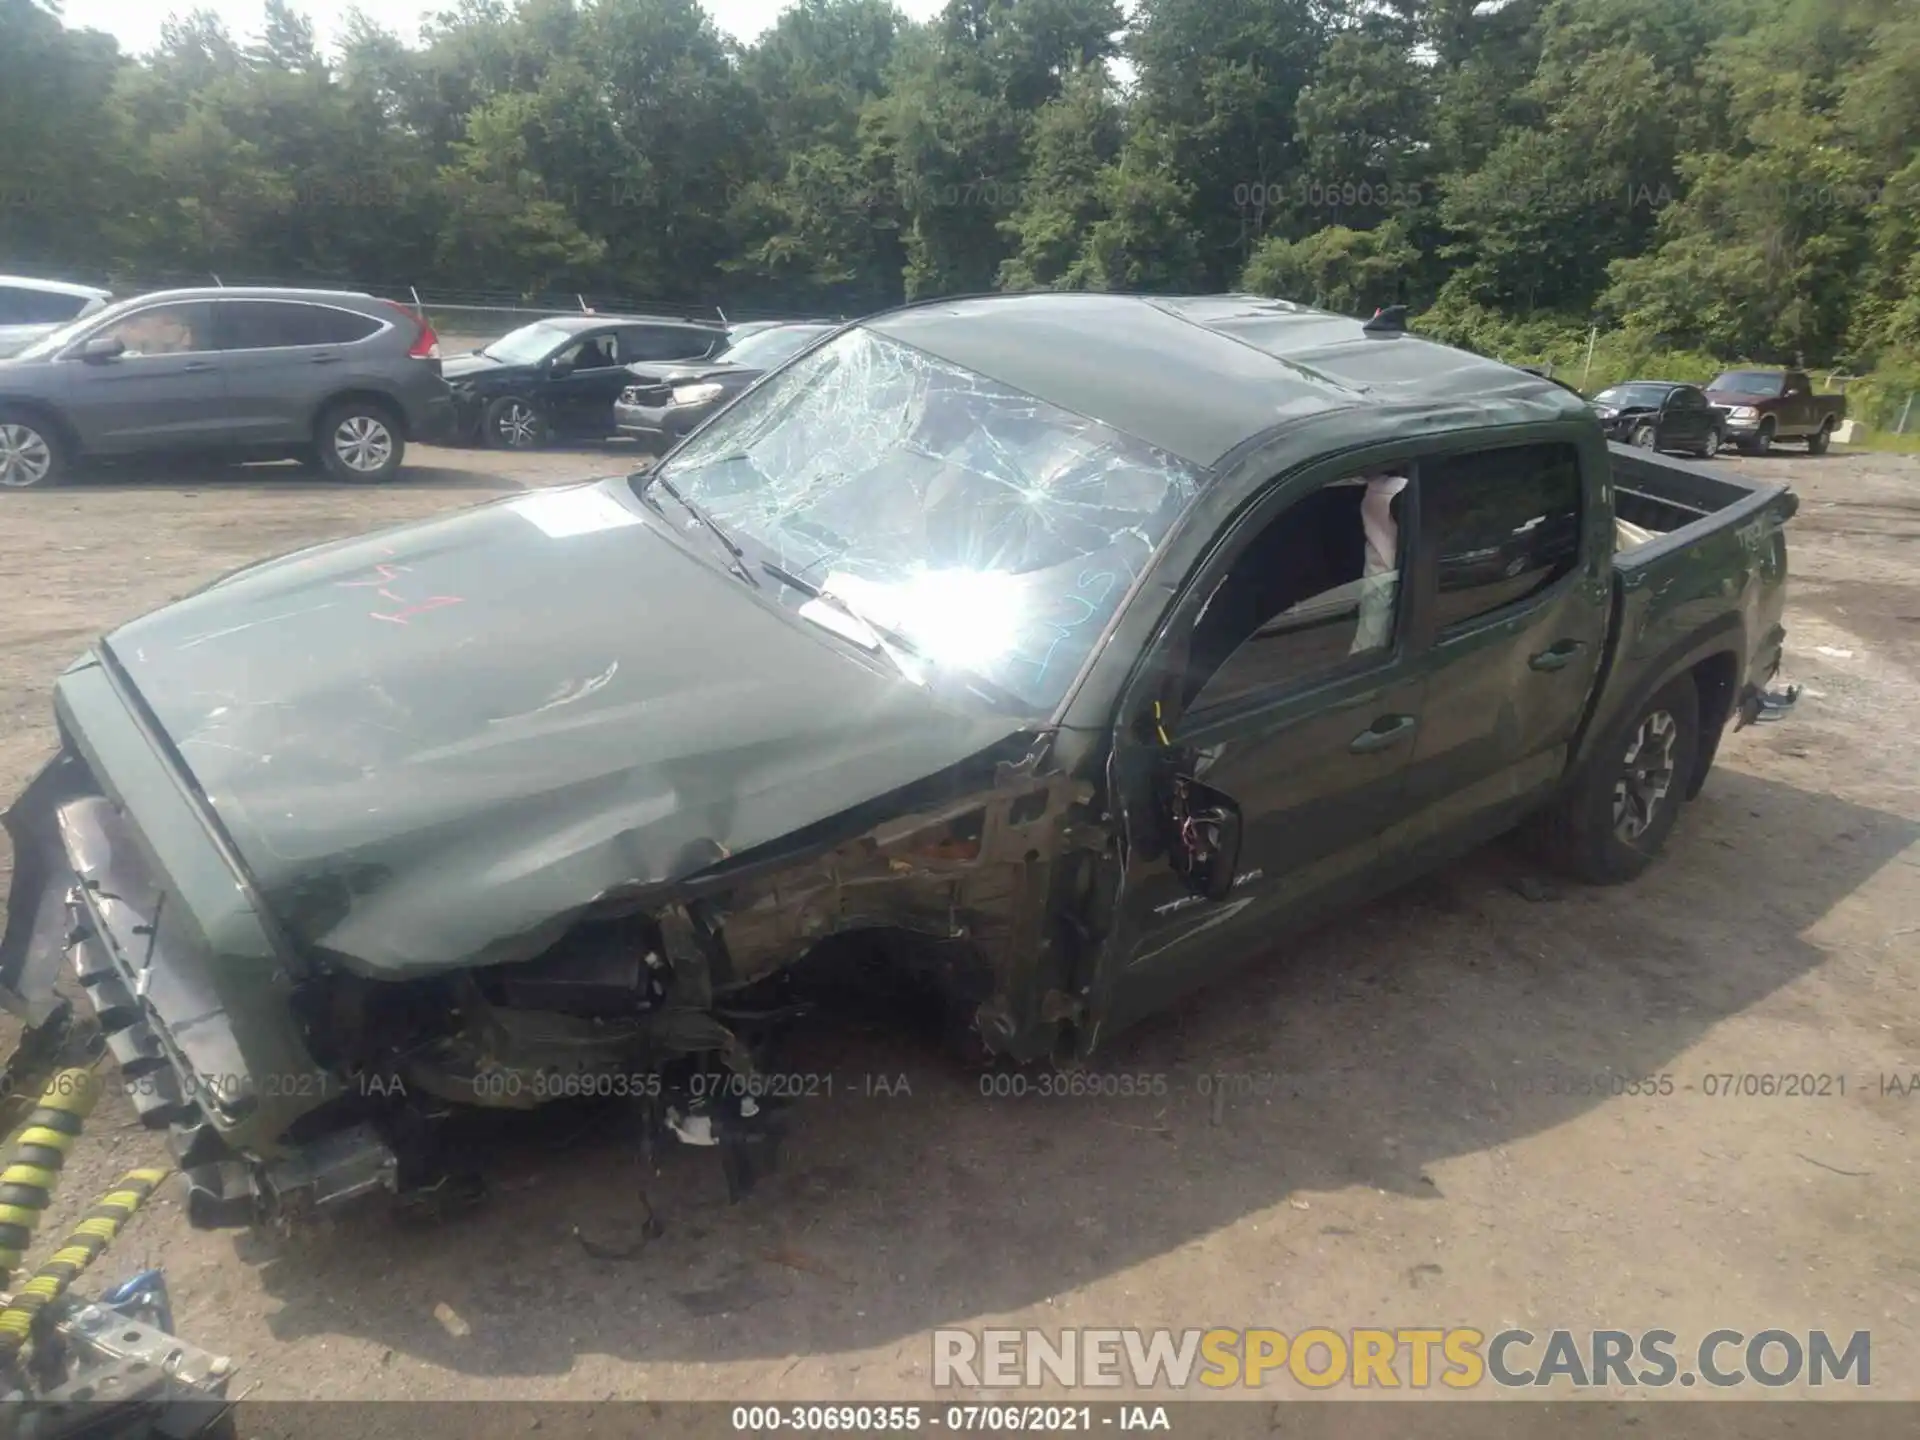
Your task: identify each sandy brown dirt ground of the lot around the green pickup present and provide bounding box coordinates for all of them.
[0,449,1920,1400]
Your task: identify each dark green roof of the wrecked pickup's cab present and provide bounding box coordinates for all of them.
[864,292,1586,467]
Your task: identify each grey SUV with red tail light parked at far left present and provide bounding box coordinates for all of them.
[0,288,453,490]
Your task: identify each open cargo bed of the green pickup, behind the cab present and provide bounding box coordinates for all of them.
[1574,444,1799,783]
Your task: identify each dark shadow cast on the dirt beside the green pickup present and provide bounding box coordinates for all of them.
[242,770,1920,1382]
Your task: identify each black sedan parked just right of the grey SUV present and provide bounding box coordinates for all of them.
[445,315,728,449]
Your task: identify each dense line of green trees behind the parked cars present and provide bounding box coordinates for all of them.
[0,0,1920,395]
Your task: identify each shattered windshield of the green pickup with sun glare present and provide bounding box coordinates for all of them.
[655,328,1202,710]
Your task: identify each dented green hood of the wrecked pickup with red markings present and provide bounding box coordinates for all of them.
[106,480,1023,975]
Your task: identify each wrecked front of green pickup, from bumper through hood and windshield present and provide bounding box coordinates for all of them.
[0,318,1200,1225]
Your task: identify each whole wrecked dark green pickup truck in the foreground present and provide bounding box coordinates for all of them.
[0,294,1795,1225]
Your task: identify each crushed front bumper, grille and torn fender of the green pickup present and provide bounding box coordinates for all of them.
[0,698,1083,1227]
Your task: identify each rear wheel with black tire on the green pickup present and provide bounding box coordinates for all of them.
[1528,676,1699,885]
